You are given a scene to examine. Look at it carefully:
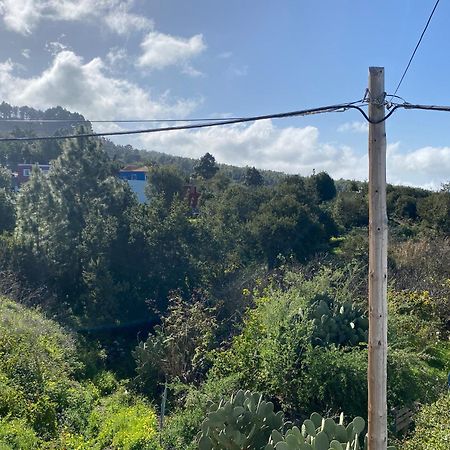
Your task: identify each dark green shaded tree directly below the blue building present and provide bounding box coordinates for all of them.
[128,195,204,313]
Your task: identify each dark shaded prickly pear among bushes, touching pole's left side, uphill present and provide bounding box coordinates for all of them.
[308,295,369,346]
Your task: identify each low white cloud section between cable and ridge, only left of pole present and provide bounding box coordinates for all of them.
[140,120,367,179]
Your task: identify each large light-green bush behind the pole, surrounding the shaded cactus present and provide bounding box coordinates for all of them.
[210,269,445,418]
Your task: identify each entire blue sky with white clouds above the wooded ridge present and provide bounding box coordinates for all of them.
[0,0,450,188]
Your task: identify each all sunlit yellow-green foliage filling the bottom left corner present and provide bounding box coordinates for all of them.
[0,298,158,450]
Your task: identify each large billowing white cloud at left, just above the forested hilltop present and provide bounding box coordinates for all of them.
[0,50,197,119]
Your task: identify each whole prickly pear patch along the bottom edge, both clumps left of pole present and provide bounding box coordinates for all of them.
[197,390,395,450]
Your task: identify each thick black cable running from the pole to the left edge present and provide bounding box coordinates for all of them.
[0,100,369,142]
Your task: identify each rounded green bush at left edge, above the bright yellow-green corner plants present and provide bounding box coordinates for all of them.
[0,298,88,438]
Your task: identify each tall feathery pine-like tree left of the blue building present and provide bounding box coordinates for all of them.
[15,138,139,324]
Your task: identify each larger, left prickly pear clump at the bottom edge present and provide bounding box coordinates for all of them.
[197,390,284,450]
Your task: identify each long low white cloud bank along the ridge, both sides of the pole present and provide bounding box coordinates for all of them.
[130,120,450,188]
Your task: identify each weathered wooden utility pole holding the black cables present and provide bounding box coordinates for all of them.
[367,67,387,450]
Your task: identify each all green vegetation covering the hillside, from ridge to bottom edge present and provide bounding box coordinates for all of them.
[0,104,450,450]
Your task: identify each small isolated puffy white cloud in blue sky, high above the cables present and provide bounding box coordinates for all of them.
[138,31,206,69]
